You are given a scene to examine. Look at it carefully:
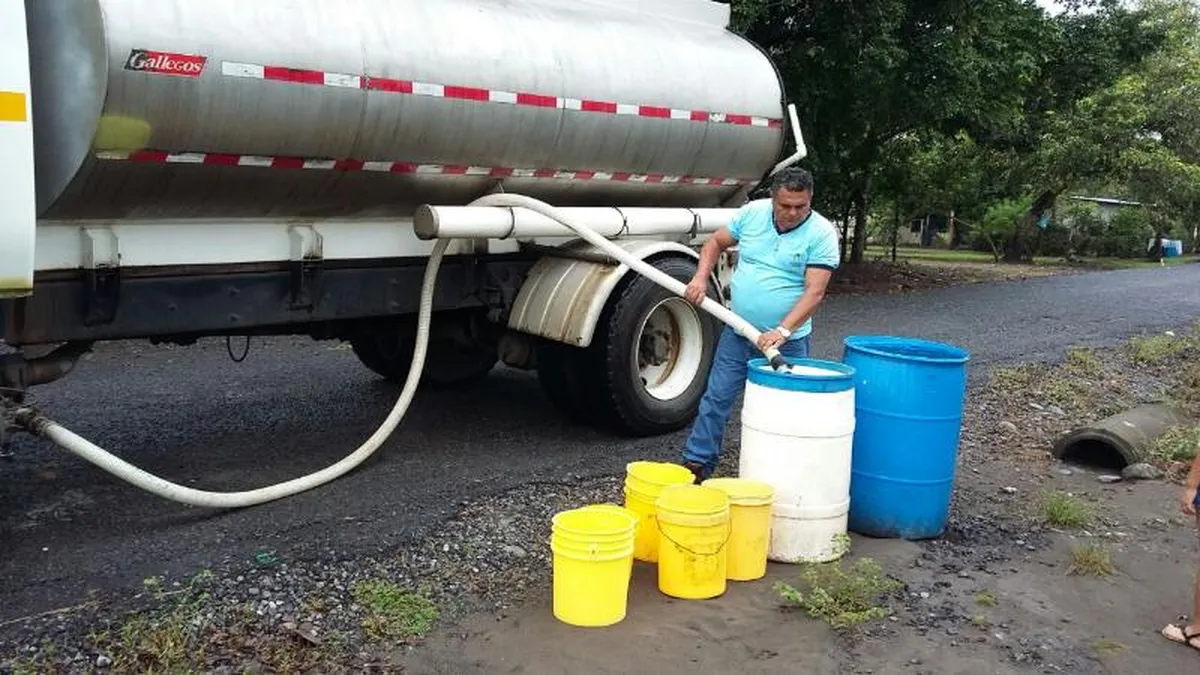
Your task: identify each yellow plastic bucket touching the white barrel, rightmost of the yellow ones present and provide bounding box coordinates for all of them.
[703,478,775,581]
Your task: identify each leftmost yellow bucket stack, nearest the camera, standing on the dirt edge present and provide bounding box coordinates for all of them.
[550,504,635,627]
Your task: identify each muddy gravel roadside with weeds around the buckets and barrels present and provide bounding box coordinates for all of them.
[0,324,1200,673]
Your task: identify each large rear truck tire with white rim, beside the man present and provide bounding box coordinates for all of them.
[539,257,720,436]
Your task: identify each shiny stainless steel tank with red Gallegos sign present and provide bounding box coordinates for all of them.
[26,0,785,220]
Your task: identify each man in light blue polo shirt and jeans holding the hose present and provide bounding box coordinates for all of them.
[683,168,841,483]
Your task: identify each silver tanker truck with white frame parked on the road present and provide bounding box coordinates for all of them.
[0,0,803,436]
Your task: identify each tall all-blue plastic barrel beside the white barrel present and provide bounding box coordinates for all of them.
[842,335,971,539]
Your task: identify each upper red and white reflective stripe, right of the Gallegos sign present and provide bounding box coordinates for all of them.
[221,61,782,129]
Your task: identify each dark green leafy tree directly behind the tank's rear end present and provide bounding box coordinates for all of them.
[734,0,1060,262]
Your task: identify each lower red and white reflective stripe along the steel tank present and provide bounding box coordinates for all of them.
[96,150,757,186]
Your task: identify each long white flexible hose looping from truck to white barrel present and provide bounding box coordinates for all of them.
[17,193,781,508]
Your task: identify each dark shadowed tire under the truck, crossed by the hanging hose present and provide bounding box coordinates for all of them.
[350,317,499,388]
